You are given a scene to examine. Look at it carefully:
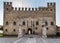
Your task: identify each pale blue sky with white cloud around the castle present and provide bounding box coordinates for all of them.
[0,0,60,26]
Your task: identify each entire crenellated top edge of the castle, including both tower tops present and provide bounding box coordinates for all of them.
[4,2,55,11]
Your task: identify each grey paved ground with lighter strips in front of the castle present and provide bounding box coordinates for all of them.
[0,37,60,43]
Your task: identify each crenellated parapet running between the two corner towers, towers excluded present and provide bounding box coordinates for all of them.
[12,7,47,11]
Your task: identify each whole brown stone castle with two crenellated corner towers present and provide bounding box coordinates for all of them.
[3,2,56,35]
